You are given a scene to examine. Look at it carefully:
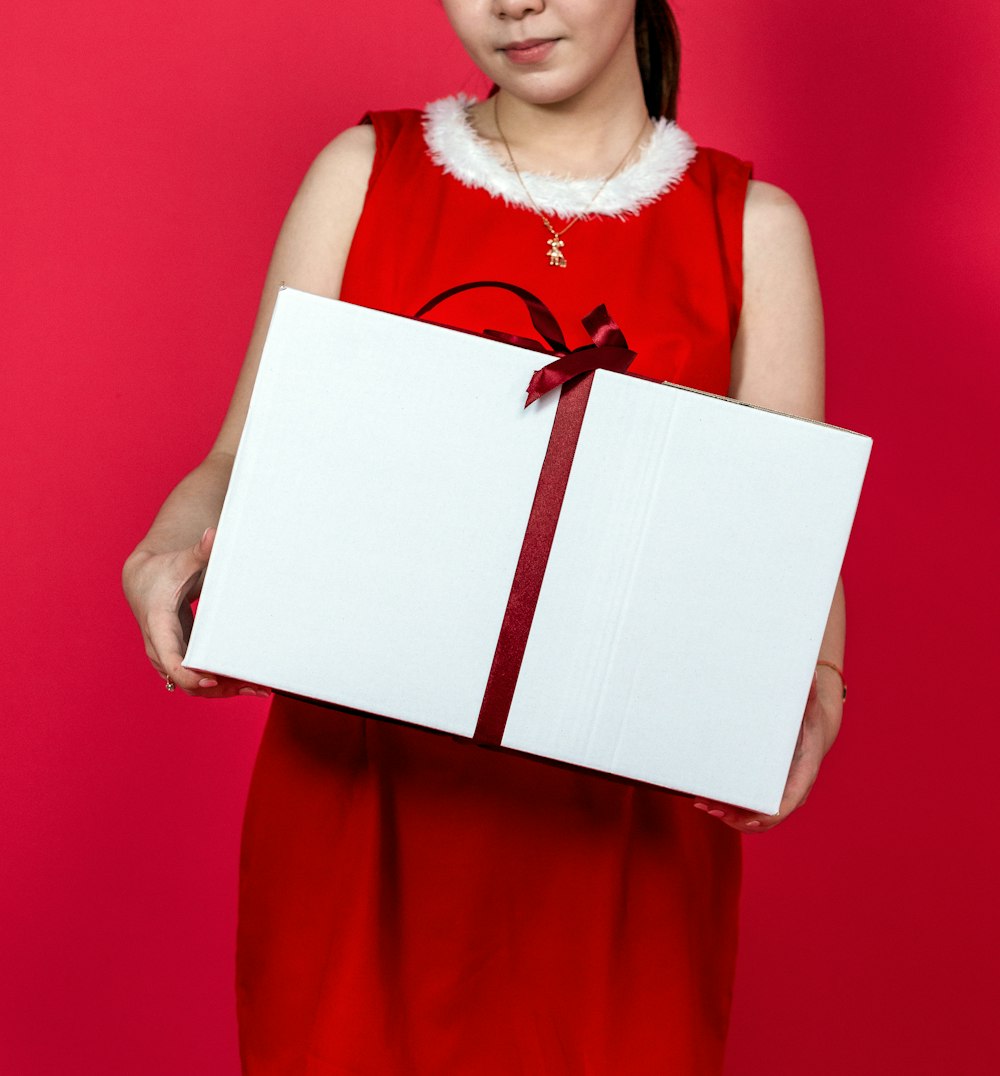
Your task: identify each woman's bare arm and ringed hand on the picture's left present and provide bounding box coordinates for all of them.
[122,126,375,696]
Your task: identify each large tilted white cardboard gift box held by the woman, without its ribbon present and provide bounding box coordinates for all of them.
[185,288,871,812]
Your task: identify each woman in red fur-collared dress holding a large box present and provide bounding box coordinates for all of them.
[125,0,844,1076]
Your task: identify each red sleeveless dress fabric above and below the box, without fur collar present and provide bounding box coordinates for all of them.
[237,102,749,1076]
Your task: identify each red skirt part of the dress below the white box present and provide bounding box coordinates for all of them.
[238,697,740,1076]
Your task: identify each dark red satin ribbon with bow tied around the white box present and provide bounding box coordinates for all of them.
[414,281,635,747]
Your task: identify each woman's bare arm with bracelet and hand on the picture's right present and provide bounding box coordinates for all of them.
[698,183,845,833]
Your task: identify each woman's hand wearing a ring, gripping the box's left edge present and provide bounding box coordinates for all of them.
[122,527,269,698]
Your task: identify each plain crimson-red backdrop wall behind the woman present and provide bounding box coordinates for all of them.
[0,0,1000,1076]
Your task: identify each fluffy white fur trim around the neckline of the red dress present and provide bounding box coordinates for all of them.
[423,94,698,218]
